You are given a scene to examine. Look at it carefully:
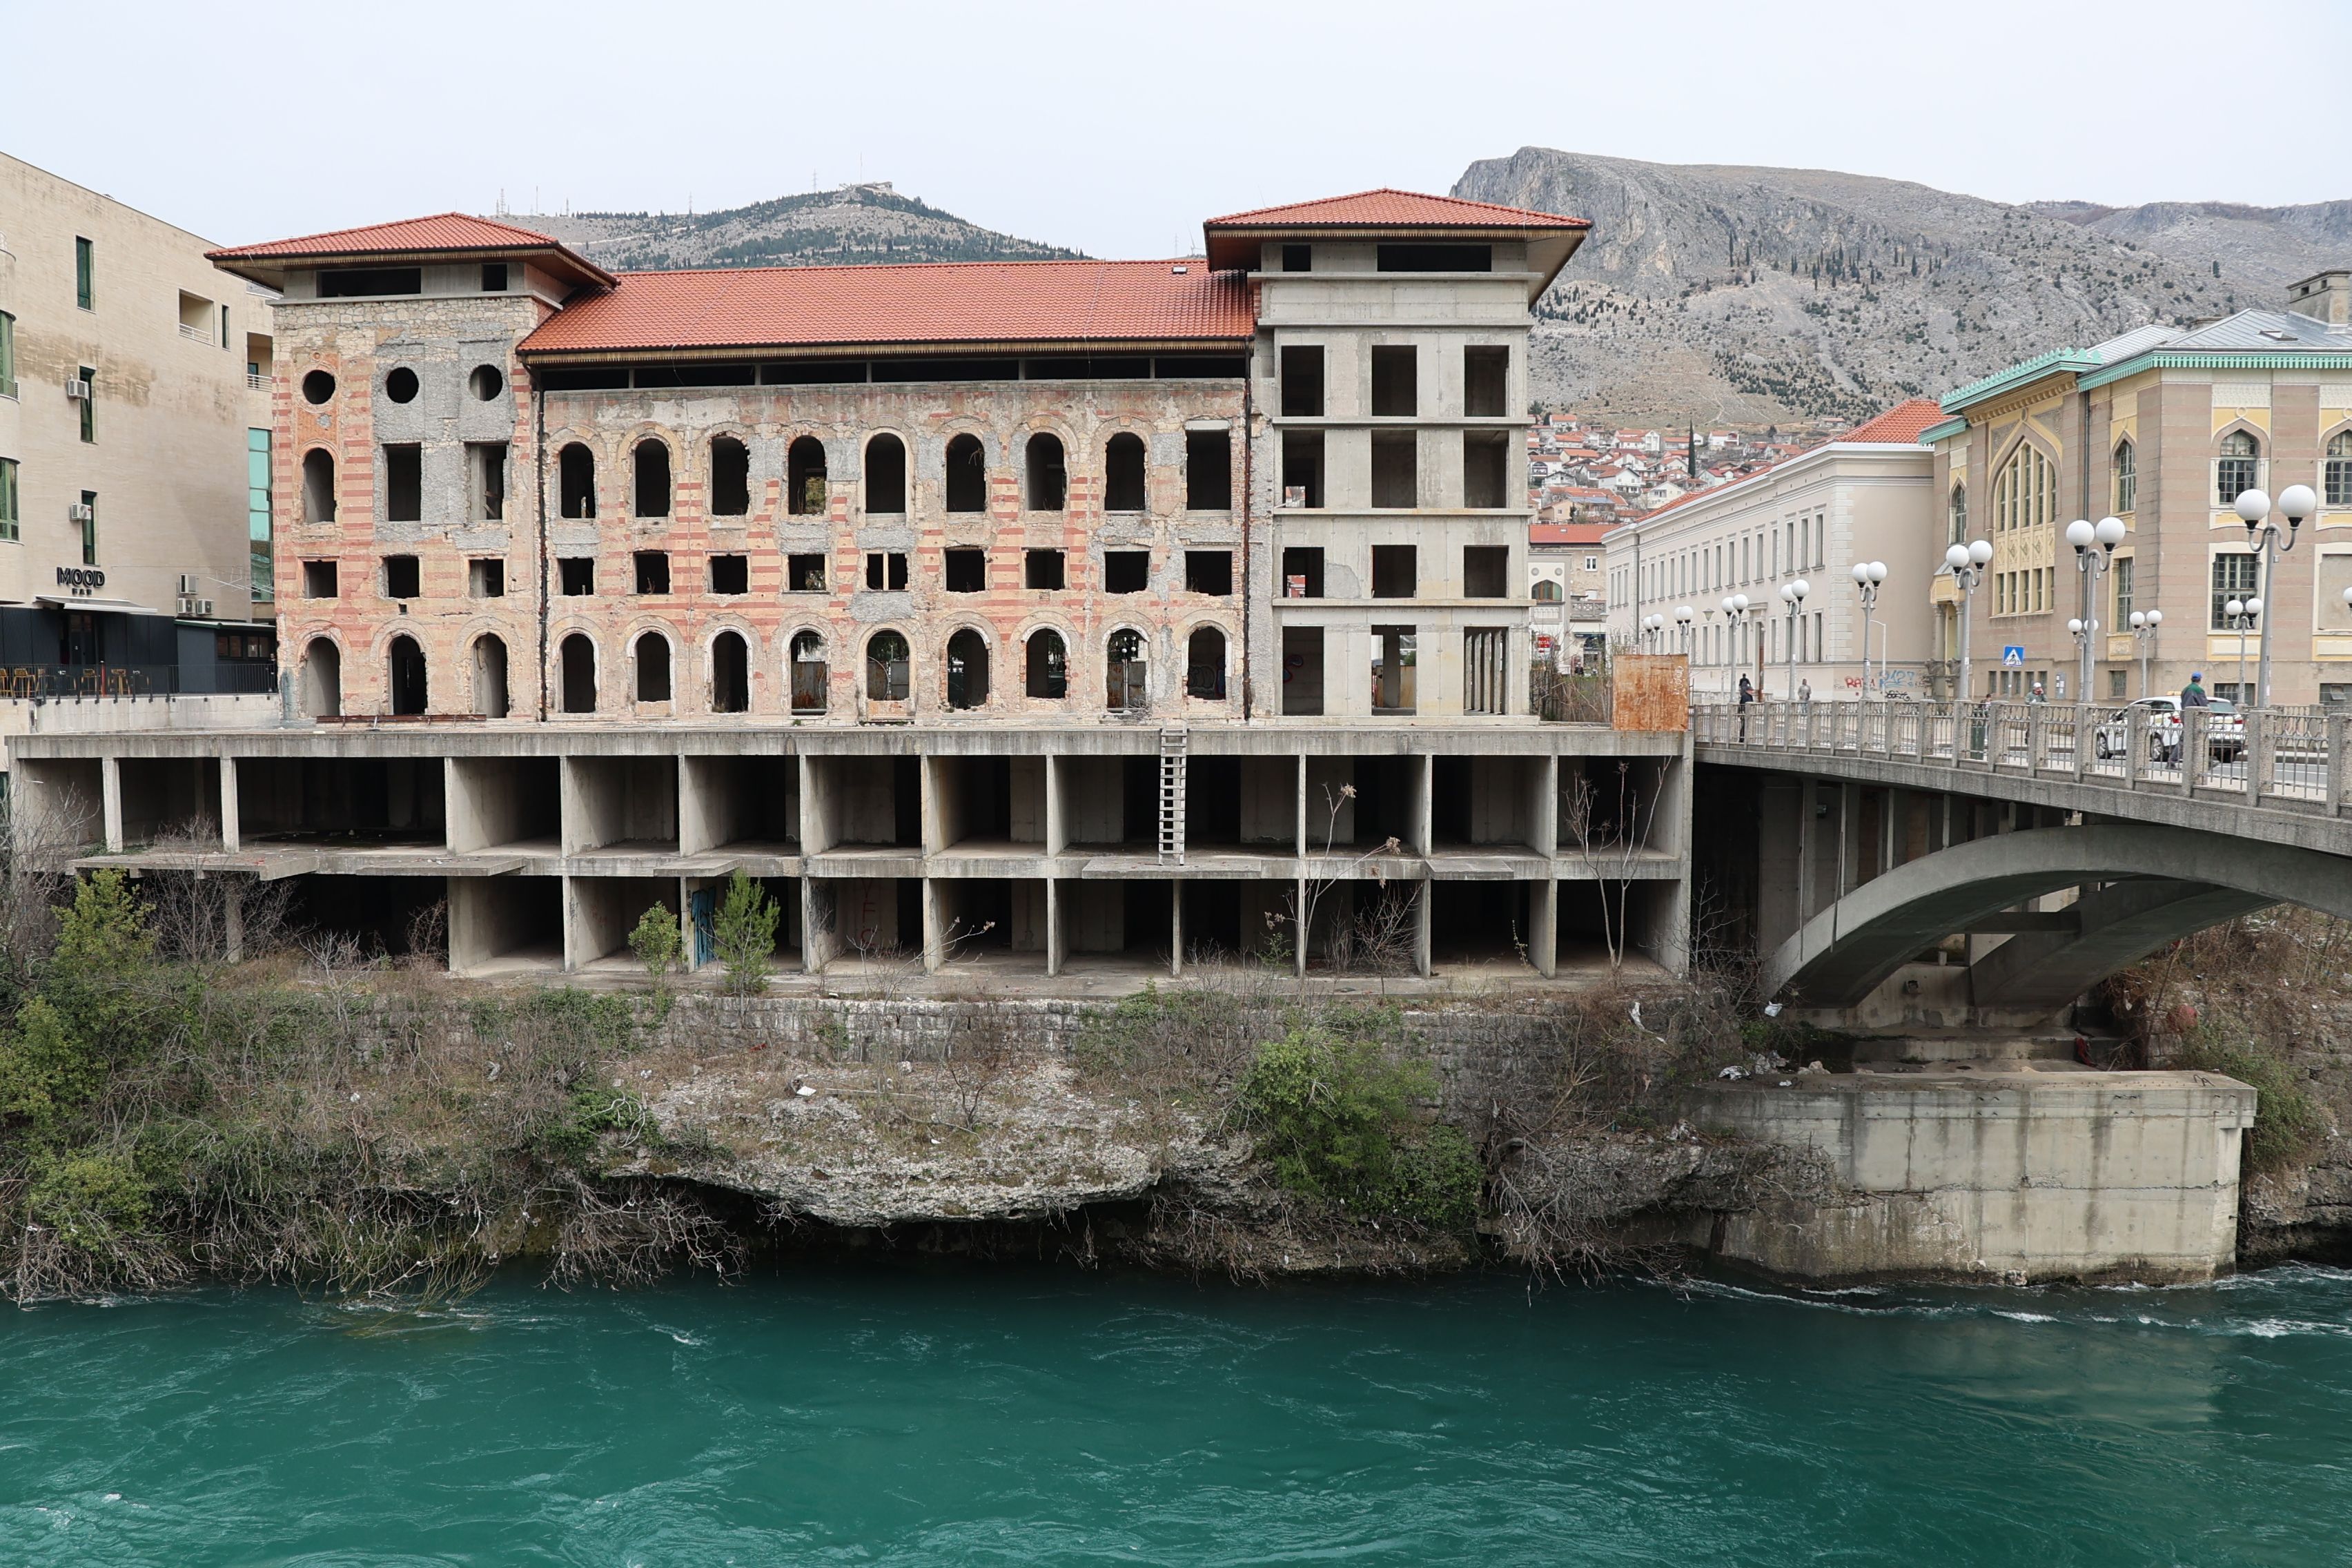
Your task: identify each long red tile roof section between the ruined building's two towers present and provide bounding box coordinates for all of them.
[522,261,1256,353]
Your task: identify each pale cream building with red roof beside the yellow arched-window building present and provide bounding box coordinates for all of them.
[1607,398,1943,698]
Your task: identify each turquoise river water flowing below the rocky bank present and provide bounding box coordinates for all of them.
[0,1265,2352,1568]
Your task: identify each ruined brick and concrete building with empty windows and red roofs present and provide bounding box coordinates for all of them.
[19,190,1687,973]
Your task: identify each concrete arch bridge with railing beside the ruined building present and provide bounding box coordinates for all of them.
[1691,700,2352,1023]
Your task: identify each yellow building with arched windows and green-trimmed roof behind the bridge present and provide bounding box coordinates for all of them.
[1921,273,2352,705]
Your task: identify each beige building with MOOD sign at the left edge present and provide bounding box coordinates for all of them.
[0,155,273,696]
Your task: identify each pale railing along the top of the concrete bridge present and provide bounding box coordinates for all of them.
[1691,698,2352,816]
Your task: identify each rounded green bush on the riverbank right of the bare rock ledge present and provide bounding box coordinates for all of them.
[1239,1028,1482,1229]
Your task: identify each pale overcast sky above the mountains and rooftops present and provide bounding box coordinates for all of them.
[0,0,2352,256]
